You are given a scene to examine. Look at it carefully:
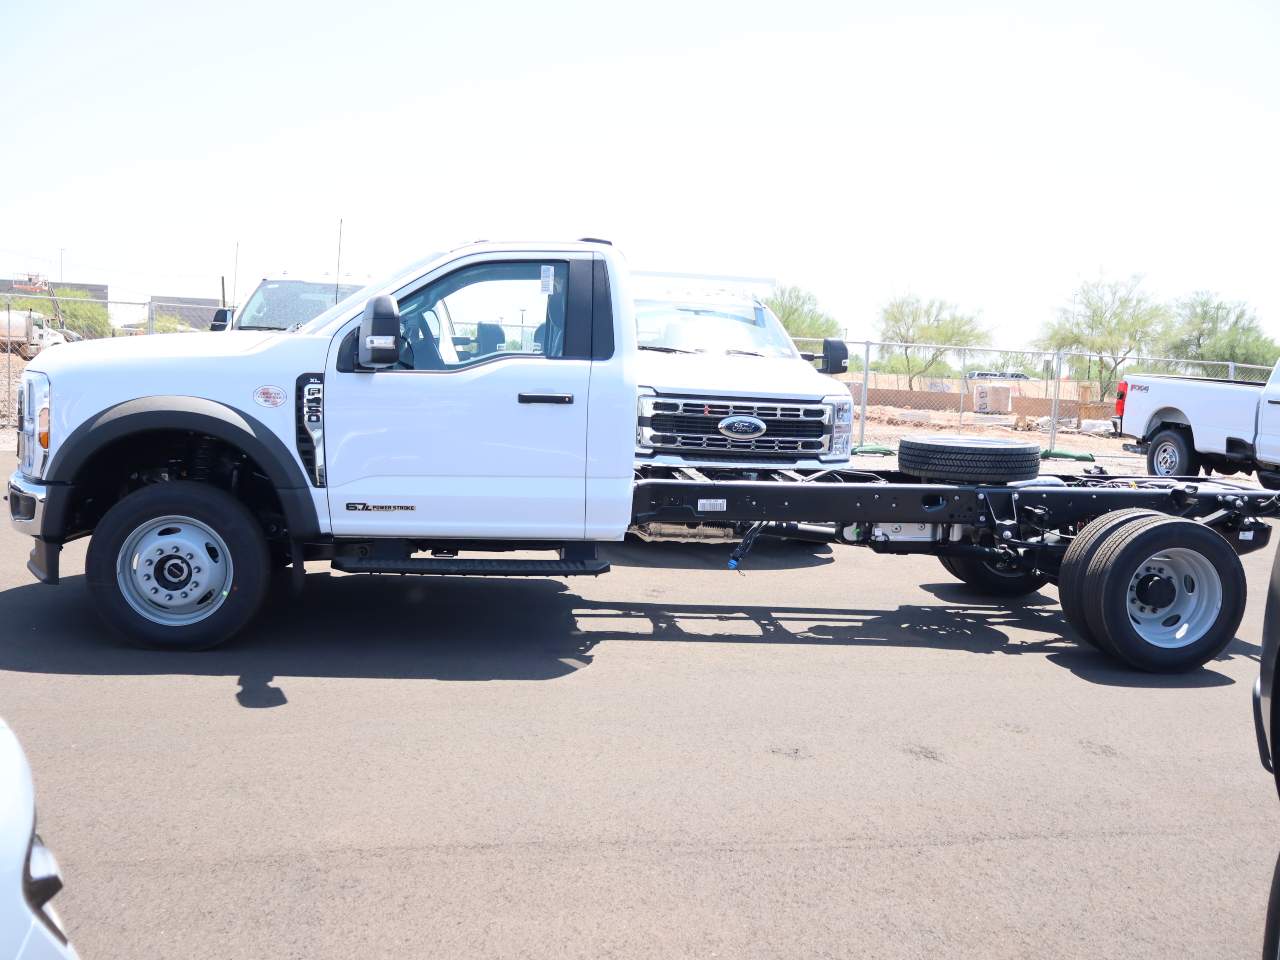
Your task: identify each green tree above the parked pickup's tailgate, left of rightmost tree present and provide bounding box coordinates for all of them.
[1038,276,1169,398]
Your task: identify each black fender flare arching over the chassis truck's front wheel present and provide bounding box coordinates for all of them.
[45,397,320,540]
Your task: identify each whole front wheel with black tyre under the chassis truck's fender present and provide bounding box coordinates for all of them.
[84,481,271,650]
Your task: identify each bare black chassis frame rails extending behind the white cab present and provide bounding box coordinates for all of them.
[632,467,1280,581]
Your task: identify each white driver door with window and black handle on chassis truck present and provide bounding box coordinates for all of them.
[325,253,591,540]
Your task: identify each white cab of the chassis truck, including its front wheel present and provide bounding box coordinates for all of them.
[9,242,636,646]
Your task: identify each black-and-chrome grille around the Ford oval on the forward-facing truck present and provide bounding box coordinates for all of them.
[640,397,831,460]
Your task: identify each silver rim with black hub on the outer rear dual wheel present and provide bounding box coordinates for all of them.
[1125,547,1222,649]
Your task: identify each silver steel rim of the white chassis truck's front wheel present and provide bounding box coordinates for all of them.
[115,517,233,626]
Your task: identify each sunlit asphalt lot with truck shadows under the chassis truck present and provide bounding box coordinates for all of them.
[0,519,1280,960]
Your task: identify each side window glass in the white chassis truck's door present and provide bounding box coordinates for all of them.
[399,261,568,370]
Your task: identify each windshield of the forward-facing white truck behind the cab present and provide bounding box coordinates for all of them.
[636,300,797,357]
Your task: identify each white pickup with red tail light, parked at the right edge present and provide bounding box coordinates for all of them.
[1116,367,1280,489]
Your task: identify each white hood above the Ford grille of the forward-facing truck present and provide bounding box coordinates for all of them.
[635,349,849,401]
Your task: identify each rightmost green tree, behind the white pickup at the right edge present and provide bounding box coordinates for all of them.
[1156,291,1280,366]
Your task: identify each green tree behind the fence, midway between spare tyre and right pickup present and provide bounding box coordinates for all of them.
[879,297,991,390]
